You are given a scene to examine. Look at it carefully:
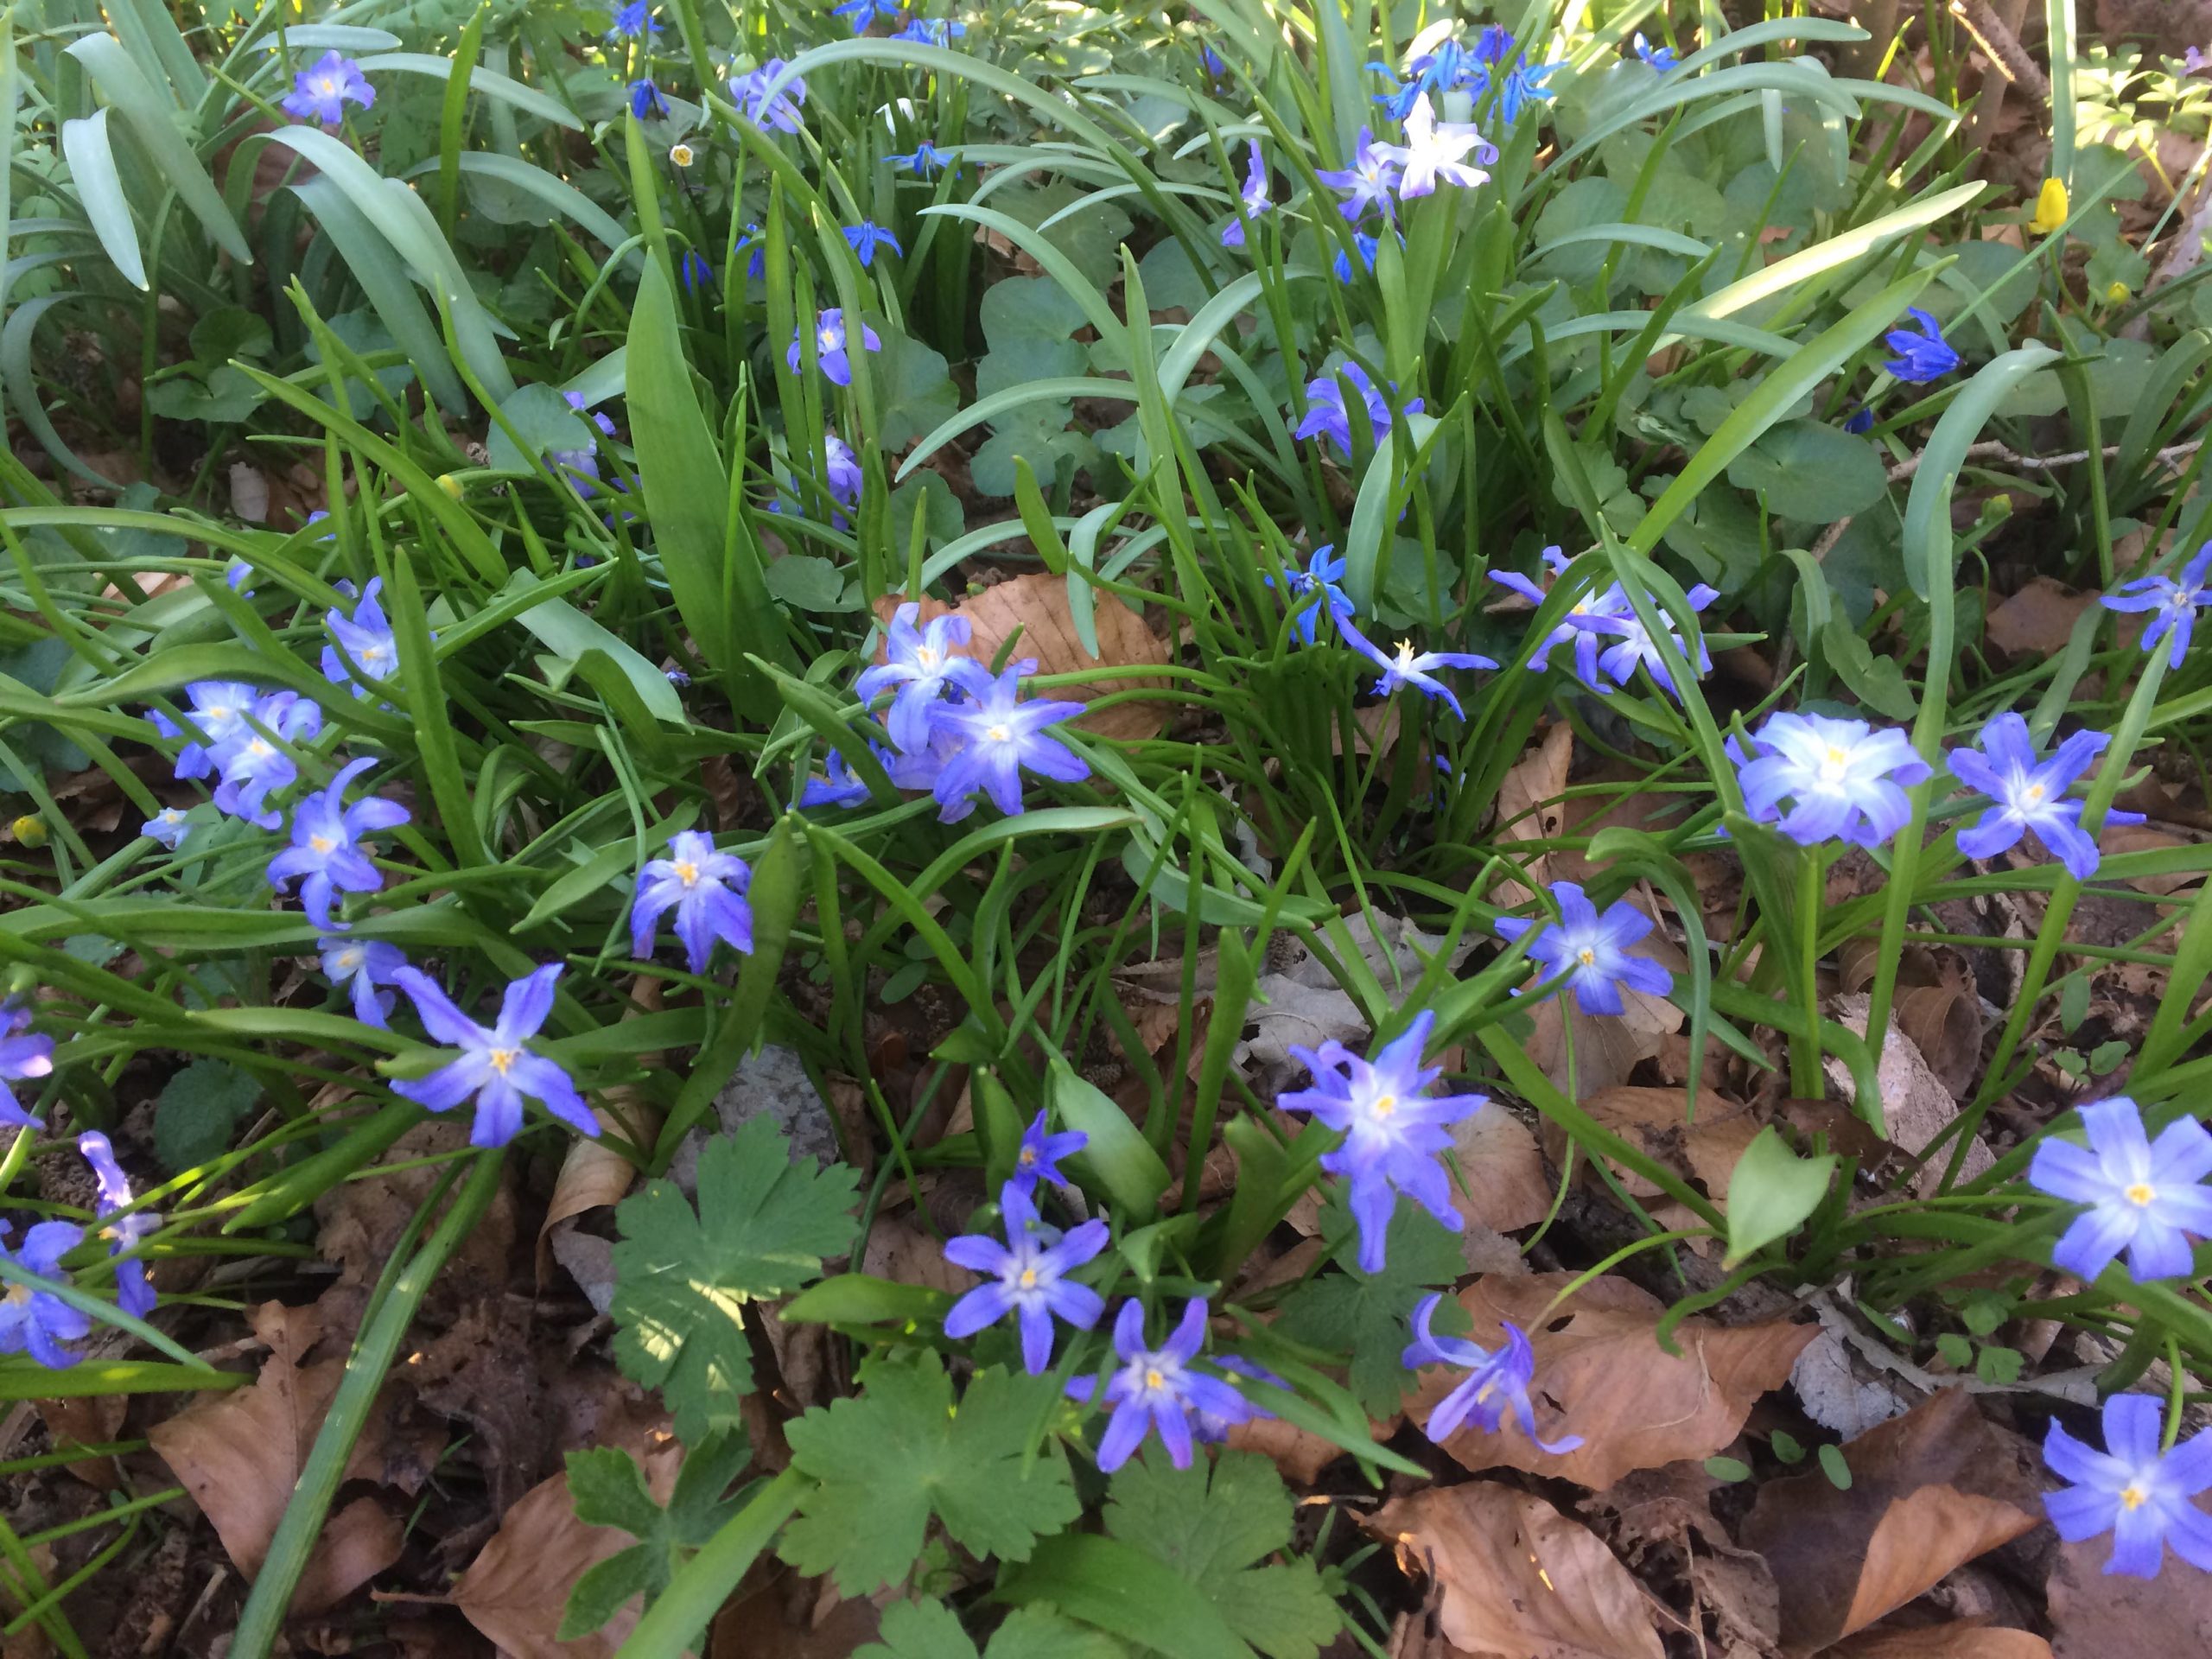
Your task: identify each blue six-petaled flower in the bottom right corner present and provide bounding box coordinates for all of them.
[2044,1394,2212,1580]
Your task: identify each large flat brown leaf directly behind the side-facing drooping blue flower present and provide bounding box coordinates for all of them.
[1411,1274,1821,1491]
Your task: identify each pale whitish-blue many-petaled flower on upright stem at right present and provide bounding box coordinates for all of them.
[1730,712,1929,847]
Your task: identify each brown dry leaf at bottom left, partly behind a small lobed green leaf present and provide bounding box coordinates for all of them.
[454,1445,683,1659]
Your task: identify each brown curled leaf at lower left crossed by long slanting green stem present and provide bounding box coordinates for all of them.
[146,1303,420,1612]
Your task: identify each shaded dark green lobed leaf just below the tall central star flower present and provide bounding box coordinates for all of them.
[1274,1197,1466,1418]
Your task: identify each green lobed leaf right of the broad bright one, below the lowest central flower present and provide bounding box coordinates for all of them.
[1106,1451,1340,1659]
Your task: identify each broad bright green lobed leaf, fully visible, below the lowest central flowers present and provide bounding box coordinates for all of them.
[779,1351,1082,1595]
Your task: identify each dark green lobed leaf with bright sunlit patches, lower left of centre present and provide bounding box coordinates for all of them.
[608,1117,858,1445]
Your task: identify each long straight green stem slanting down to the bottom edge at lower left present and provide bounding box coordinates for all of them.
[230,1153,505,1659]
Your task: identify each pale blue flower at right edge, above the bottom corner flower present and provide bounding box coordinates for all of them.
[2029,1095,2212,1283]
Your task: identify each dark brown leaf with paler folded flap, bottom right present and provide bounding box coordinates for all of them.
[1743,1389,2042,1648]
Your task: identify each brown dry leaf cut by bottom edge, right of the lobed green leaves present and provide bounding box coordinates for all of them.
[1367,1480,1666,1659]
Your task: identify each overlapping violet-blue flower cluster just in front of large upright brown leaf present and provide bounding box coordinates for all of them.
[801,601,1090,823]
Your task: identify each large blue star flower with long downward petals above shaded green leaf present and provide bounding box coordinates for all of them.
[1274,1011,1489,1274]
